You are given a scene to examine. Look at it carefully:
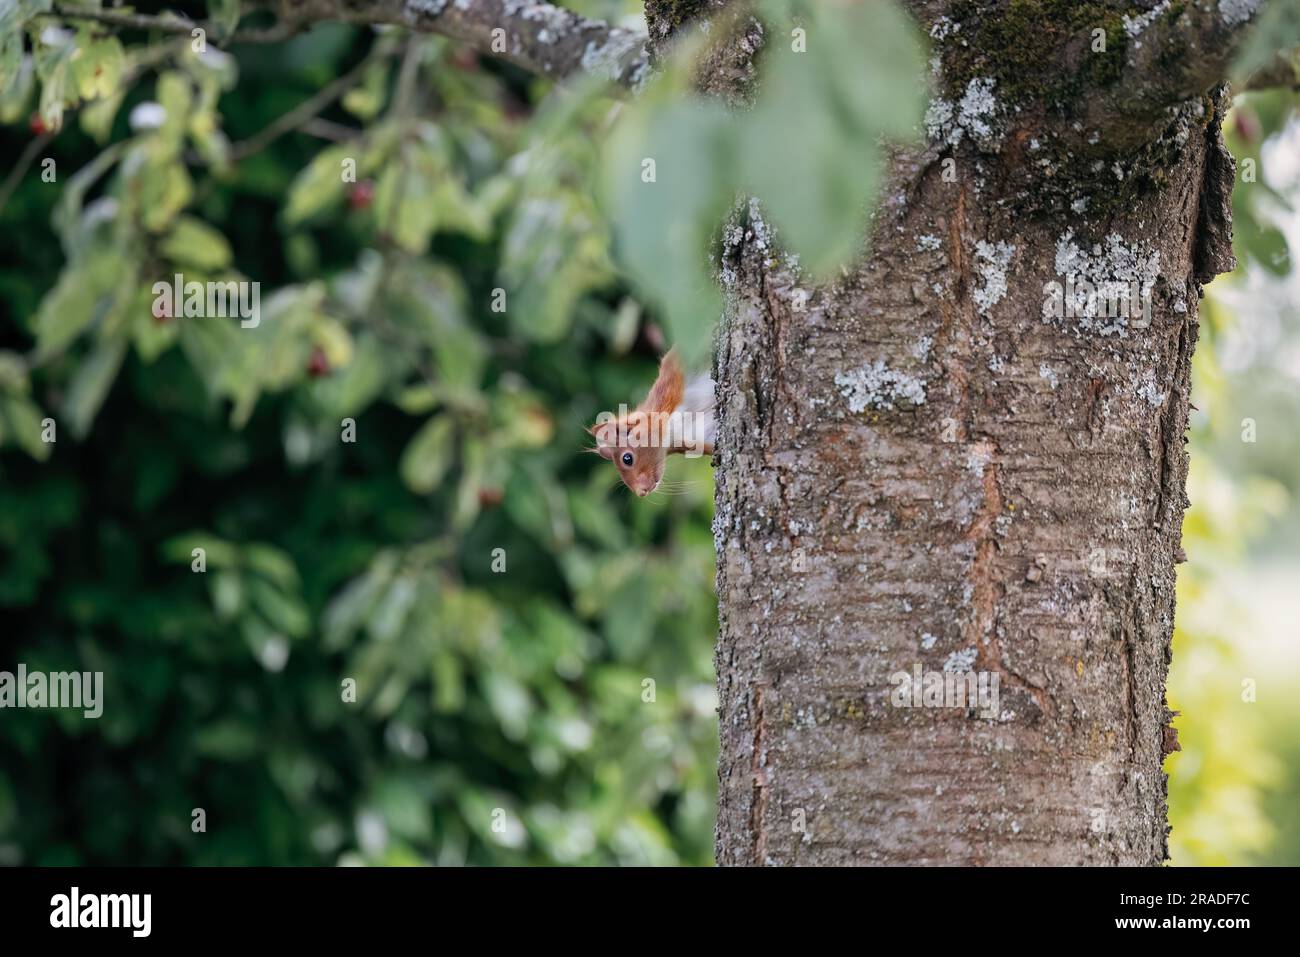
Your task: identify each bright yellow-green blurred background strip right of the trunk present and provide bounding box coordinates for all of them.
[1166,85,1300,865]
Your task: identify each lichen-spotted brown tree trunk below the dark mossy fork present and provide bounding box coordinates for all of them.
[665,1,1234,865]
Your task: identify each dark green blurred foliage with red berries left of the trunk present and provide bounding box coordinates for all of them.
[0,0,716,865]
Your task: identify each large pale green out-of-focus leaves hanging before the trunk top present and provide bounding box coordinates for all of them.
[602,0,927,359]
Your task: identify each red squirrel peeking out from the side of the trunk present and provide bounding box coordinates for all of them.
[588,348,718,498]
